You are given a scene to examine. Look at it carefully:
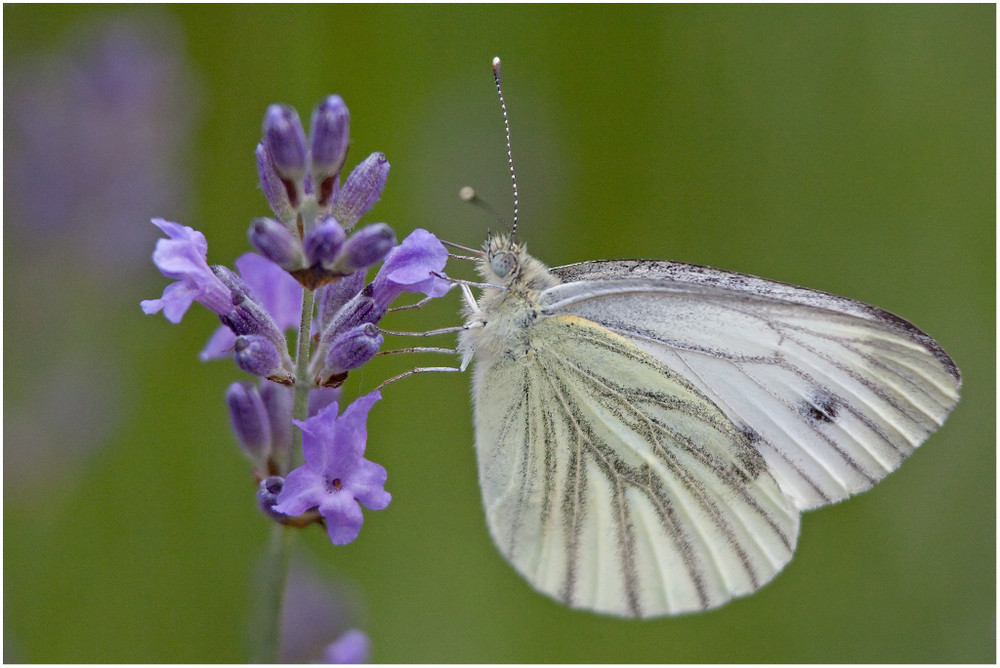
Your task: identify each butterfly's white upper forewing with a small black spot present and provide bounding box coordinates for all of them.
[540,260,961,509]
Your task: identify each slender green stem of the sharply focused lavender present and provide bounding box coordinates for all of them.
[253,289,314,663]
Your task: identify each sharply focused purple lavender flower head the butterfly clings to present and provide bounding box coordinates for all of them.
[142,85,451,663]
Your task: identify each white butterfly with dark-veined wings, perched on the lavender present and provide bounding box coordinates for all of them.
[459,61,962,617]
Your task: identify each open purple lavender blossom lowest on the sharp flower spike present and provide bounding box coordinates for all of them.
[274,391,392,545]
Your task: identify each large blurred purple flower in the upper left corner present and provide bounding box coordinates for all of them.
[4,13,198,274]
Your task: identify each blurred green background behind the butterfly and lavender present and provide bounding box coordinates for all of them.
[3,5,996,663]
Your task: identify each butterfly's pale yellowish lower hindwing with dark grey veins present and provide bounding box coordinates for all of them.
[474,316,799,617]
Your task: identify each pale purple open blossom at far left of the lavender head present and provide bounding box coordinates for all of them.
[140,218,233,324]
